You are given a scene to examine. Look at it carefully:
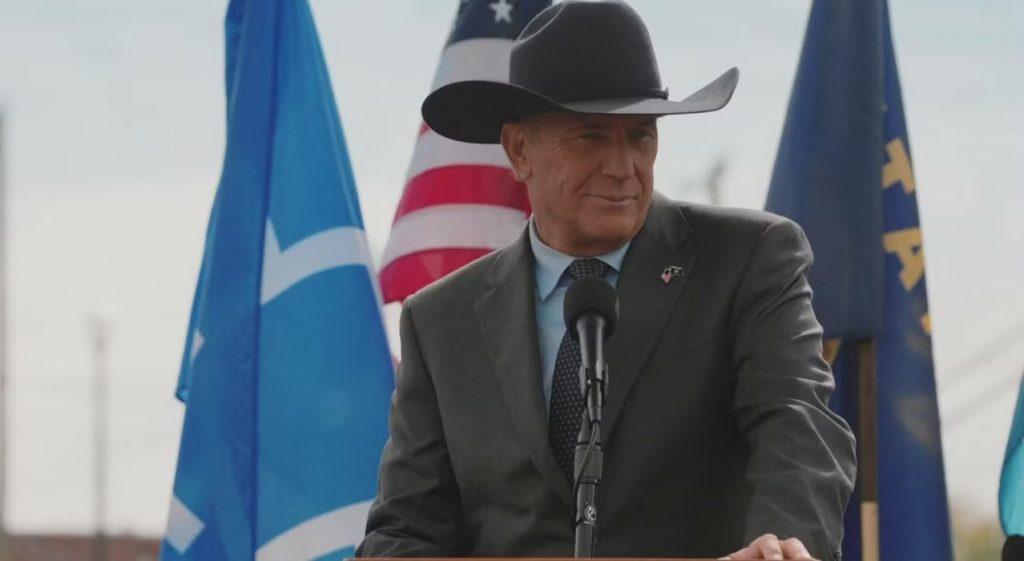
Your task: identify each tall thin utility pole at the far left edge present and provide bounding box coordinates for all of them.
[0,107,7,561]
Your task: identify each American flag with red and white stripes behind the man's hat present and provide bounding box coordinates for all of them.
[380,0,551,302]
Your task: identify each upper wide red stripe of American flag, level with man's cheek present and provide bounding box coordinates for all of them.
[395,166,530,220]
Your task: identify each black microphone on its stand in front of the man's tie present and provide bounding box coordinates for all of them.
[563,276,618,558]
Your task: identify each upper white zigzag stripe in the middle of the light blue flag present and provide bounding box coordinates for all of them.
[260,219,381,304]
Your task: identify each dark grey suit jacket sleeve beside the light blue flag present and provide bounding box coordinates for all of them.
[355,302,464,557]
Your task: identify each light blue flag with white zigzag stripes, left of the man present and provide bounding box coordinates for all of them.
[161,0,393,561]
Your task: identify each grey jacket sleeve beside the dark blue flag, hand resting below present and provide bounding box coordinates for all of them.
[731,219,856,560]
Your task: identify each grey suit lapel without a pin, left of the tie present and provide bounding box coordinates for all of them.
[476,231,571,506]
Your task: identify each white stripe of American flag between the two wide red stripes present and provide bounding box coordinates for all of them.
[383,205,526,266]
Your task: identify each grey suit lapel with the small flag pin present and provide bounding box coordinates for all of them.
[601,196,696,441]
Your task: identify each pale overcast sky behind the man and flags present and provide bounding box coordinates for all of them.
[0,0,1024,534]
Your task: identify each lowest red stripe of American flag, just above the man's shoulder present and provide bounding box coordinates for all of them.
[380,249,490,302]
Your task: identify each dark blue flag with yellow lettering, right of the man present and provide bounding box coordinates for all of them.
[767,0,952,561]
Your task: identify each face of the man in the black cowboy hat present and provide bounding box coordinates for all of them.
[502,114,657,257]
